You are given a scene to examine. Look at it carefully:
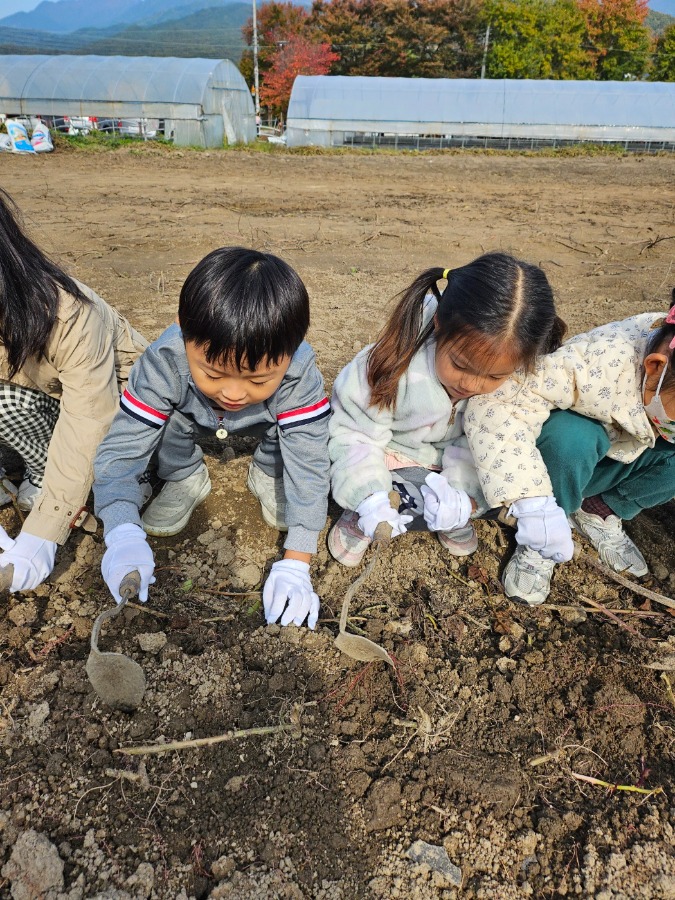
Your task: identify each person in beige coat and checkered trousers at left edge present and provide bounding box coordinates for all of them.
[0,189,147,591]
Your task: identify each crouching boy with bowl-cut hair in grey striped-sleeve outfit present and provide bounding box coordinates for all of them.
[94,247,330,628]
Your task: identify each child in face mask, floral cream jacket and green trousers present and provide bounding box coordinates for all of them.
[465,290,675,606]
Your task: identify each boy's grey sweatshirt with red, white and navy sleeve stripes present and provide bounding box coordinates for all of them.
[94,325,330,553]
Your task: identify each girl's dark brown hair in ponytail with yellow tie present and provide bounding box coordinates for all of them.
[367,253,565,409]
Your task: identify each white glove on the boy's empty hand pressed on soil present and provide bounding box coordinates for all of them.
[263,559,319,628]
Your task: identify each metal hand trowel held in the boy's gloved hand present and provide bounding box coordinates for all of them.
[86,572,145,712]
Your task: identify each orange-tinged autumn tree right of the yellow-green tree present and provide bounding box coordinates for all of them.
[579,0,651,81]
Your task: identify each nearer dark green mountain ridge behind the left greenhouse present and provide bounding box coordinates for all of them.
[0,0,251,63]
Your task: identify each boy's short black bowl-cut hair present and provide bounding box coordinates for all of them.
[178,247,309,370]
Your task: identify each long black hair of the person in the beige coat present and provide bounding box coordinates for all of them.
[0,188,88,378]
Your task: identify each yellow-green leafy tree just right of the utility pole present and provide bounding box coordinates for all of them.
[483,0,592,79]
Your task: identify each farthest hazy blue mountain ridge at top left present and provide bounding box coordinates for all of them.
[0,0,247,34]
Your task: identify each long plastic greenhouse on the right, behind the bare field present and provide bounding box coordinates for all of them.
[286,75,675,150]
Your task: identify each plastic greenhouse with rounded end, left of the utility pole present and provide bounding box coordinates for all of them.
[0,56,256,147]
